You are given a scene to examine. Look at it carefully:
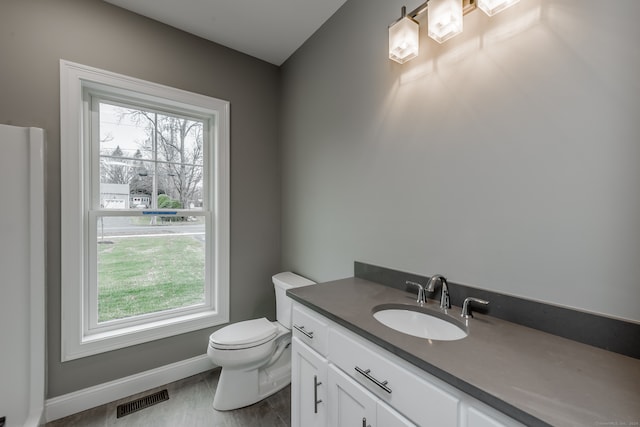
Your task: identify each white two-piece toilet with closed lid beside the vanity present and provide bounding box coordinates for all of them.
[207,272,315,411]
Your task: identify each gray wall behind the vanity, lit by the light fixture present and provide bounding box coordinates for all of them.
[281,0,640,321]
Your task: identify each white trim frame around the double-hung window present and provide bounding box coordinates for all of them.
[60,60,230,362]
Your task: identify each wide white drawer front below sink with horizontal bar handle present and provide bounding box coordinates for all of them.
[329,329,460,427]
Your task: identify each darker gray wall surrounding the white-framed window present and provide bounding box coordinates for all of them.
[0,0,280,397]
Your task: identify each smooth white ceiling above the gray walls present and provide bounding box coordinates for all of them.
[104,0,346,65]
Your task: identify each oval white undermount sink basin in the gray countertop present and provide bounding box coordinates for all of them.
[373,304,468,341]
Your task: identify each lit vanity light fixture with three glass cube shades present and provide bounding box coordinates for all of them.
[389,0,520,64]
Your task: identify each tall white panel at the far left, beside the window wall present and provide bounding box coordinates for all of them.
[0,124,45,427]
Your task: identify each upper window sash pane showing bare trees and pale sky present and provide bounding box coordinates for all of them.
[99,102,206,209]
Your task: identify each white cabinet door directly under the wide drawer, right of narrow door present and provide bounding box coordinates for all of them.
[328,365,377,427]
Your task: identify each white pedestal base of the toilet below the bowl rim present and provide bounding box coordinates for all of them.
[213,348,291,411]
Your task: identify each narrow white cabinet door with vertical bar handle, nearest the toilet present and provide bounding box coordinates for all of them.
[291,337,327,427]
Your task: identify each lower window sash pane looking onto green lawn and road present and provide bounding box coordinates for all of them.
[97,215,205,323]
